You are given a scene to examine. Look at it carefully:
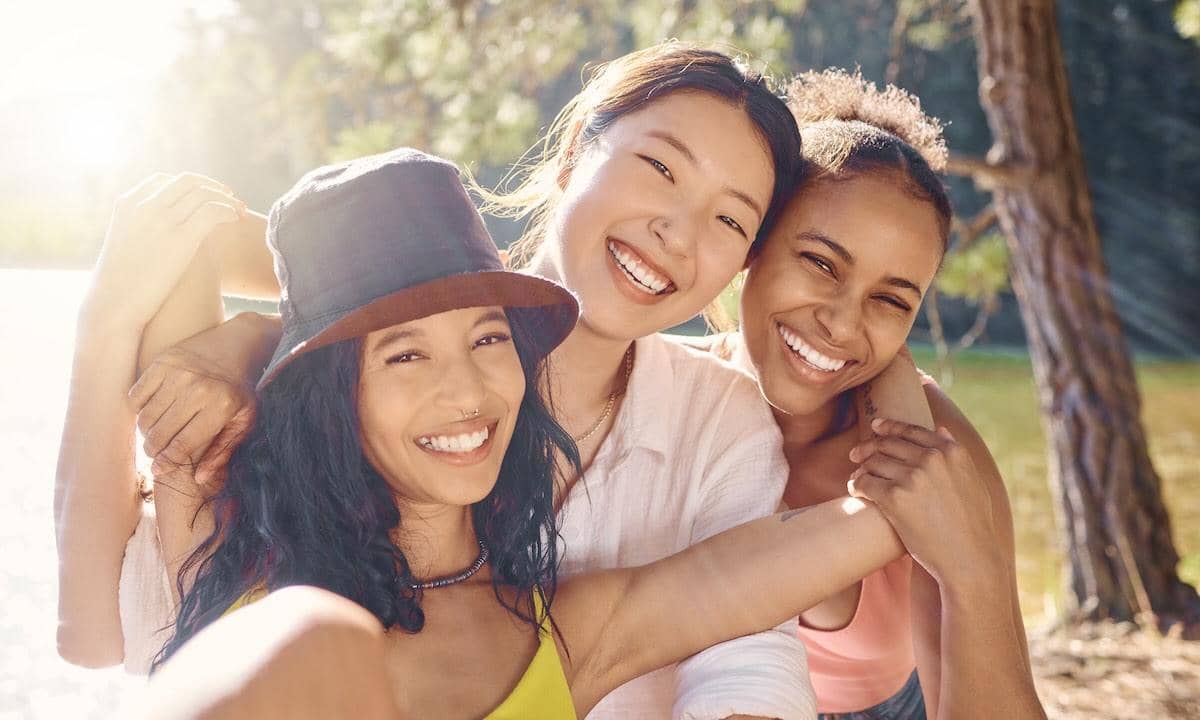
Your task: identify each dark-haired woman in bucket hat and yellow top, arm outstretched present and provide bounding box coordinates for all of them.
[71,150,902,718]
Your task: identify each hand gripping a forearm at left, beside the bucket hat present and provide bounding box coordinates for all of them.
[130,313,280,491]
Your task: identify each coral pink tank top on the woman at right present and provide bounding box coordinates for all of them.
[800,556,917,713]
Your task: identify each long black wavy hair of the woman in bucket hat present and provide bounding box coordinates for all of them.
[152,313,580,671]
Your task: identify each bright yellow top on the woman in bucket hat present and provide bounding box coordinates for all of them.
[224,588,577,720]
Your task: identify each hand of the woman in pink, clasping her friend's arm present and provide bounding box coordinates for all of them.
[847,419,1003,583]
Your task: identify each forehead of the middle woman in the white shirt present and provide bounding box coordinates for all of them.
[601,90,775,198]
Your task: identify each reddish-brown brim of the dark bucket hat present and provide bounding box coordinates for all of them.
[257,270,578,391]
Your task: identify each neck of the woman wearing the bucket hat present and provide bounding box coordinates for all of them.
[392,502,479,582]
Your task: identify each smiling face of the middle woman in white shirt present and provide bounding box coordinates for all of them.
[542,91,774,340]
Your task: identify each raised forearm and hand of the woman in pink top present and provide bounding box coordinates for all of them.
[854,362,1044,718]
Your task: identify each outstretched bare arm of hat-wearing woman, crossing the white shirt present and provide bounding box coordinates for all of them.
[556,498,902,712]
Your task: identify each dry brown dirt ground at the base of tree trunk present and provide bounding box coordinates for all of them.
[1030,623,1200,720]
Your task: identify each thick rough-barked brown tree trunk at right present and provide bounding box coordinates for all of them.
[970,0,1200,625]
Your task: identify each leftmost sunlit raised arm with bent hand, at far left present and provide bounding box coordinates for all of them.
[54,175,241,666]
